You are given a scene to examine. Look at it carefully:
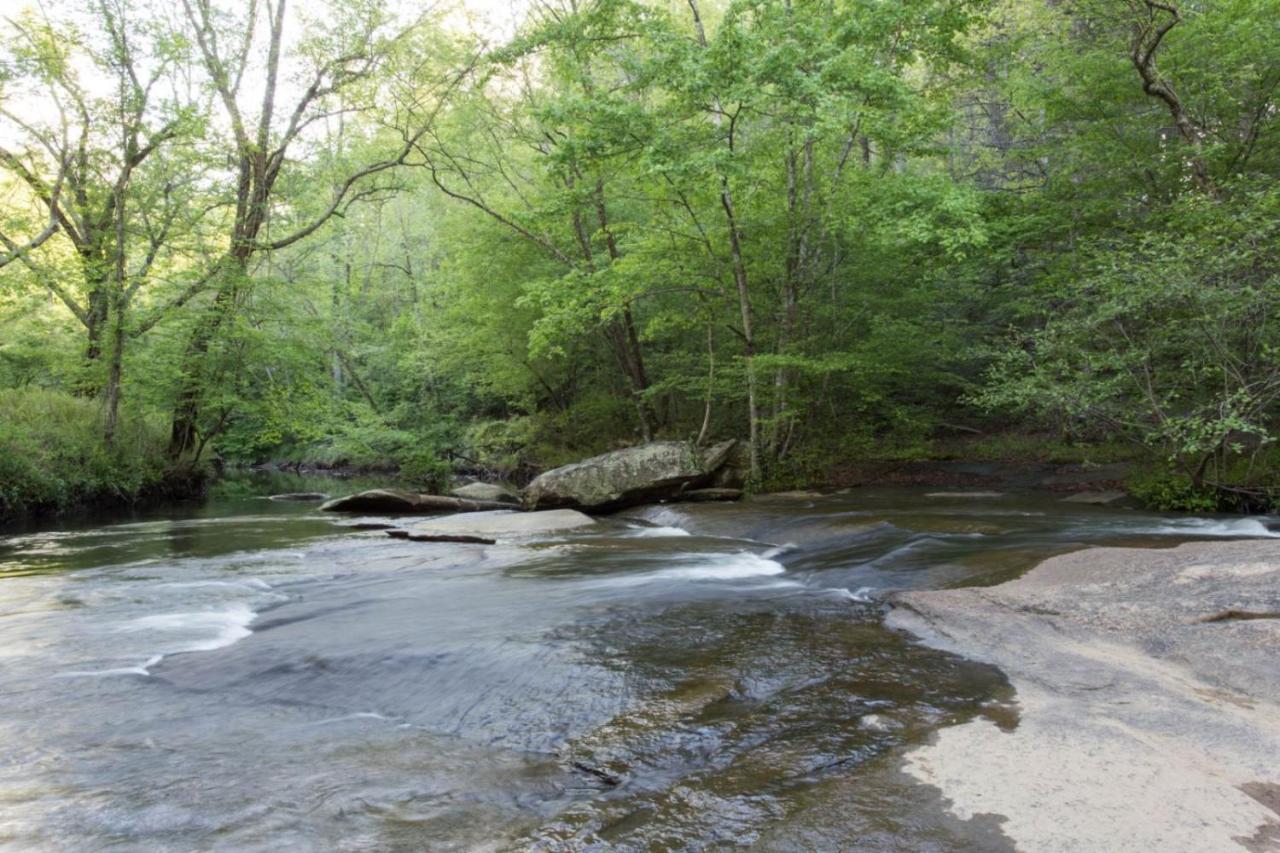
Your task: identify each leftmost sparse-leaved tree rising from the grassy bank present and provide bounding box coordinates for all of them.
[0,0,193,442]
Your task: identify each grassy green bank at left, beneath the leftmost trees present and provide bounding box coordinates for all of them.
[0,388,189,519]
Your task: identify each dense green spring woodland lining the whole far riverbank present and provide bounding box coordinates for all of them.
[0,0,1280,512]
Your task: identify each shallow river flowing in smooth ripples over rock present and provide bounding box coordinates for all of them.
[0,479,1276,850]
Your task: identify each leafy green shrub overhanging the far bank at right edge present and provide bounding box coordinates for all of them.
[978,183,1280,476]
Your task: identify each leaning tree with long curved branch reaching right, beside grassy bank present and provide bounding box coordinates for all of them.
[162,0,458,457]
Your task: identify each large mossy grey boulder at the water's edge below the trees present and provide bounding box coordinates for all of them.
[525,441,736,512]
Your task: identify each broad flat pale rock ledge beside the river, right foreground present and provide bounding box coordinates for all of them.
[887,540,1280,853]
